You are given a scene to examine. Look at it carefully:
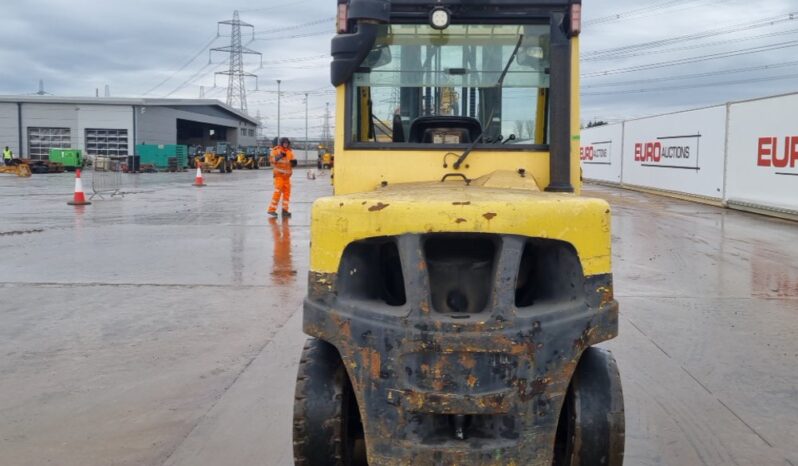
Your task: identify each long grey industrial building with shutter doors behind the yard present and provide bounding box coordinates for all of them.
[0,96,258,160]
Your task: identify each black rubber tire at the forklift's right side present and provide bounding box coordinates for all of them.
[552,347,626,466]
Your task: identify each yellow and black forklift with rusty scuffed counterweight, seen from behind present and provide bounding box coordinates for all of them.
[293,0,625,466]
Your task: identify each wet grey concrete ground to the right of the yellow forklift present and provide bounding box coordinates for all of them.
[585,186,798,466]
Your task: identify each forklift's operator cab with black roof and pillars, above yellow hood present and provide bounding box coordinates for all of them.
[332,0,581,194]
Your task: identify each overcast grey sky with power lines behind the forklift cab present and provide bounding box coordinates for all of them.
[0,0,798,136]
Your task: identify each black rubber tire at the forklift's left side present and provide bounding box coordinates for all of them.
[293,338,368,466]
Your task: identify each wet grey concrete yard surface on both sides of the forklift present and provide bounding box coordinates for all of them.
[0,171,798,466]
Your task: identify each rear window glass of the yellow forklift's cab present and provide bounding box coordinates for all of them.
[349,24,550,144]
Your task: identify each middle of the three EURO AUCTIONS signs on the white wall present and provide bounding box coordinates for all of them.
[634,134,701,170]
